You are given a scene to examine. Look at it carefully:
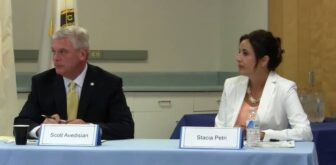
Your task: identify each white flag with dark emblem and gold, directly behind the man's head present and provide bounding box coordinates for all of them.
[38,0,78,72]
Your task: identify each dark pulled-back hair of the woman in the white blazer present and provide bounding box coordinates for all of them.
[239,30,284,70]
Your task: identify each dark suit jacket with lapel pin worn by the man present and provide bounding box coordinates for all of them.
[14,64,134,139]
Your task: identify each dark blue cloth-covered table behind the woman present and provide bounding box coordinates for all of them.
[170,114,336,165]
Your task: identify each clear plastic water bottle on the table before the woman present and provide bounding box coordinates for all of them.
[246,107,260,147]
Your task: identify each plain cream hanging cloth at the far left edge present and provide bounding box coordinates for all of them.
[0,0,18,136]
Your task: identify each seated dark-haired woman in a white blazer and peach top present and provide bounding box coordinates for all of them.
[215,30,313,141]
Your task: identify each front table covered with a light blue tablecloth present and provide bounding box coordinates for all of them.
[0,139,318,165]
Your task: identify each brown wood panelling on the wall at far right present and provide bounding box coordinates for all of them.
[268,0,336,117]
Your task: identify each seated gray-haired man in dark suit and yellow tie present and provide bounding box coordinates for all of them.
[14,26,134,139]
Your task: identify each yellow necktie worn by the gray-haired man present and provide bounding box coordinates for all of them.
[67,81,78,120]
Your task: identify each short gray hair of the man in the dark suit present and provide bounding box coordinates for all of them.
[52,26,90,50]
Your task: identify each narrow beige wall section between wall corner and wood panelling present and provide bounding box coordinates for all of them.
[217,0,268,71]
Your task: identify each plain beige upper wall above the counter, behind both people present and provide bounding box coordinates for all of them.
[12,0,268,72]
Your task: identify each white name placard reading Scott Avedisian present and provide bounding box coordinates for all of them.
[38,124,101,146]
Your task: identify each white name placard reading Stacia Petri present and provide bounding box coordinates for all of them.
[180,127,243,149]
